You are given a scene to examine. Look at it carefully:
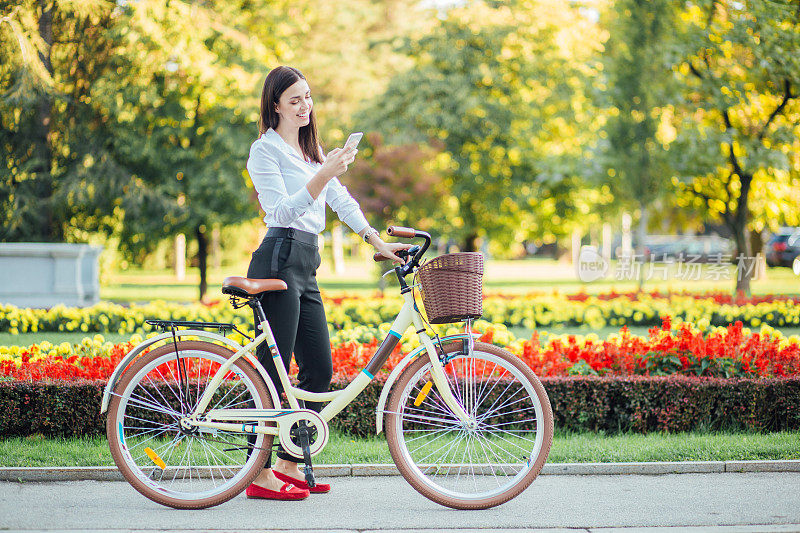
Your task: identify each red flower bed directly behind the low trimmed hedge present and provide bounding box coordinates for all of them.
[0,317,800,381]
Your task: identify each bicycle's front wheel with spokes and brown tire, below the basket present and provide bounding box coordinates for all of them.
[386,343,553,509]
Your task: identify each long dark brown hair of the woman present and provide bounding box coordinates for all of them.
[258,66,322,163]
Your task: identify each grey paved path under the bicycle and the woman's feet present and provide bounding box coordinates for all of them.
[0,472,800,533]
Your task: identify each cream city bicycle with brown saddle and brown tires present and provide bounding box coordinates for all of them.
[101,226,553,509]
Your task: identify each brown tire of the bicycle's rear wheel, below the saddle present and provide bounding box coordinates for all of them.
[106,341,273,509]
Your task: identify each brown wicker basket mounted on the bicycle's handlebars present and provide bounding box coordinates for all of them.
[418,252,483,324]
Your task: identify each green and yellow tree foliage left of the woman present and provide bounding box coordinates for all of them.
[0,0,278,297]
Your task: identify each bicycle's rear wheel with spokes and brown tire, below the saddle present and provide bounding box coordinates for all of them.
[106,341,273,509]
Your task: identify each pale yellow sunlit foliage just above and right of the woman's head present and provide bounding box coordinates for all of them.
[260,0,437,145]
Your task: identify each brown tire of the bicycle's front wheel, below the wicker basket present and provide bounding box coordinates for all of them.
[385,342,553,510]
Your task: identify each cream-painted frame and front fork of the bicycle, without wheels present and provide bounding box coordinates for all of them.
[186,291,469,435]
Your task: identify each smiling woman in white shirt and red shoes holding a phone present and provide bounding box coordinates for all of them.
[246,66,410,500]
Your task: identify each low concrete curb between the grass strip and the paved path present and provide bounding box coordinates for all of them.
[0,459,800,482]
